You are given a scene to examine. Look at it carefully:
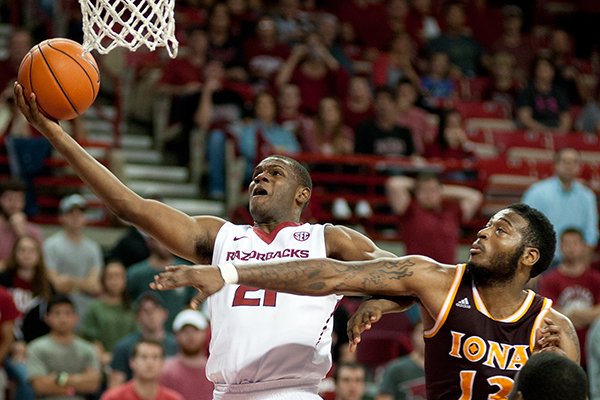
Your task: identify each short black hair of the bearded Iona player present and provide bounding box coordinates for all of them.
[507,203,556,278]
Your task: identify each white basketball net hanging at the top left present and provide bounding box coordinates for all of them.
[79,0,179,58]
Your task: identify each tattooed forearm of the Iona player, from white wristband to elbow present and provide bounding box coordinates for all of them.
[237,257,415,296]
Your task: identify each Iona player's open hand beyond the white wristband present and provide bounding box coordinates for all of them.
[150,265,225,308]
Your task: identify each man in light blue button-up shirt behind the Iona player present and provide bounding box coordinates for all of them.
[523,147,598,262]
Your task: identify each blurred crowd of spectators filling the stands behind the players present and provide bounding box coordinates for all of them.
[0,0,600,400]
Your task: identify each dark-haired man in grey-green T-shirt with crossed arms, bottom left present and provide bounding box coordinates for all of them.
[27,295,101,400]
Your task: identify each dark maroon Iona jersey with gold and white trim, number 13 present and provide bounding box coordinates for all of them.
[424,264,552,400]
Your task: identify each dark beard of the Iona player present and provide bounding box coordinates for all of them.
[467,246,525,287]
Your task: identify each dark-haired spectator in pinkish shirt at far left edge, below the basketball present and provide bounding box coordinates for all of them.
[0,179,44,270]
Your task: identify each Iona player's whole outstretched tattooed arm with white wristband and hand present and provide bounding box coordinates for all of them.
[151,256,455,306]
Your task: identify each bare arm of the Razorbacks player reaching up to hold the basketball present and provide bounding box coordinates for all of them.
[15,84,224,262]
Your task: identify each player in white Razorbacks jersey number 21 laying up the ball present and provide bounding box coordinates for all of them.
[15,84,406,400]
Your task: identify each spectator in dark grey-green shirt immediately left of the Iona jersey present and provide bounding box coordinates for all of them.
[375,322,427,400]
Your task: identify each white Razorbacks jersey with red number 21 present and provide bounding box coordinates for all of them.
[206,222,340,392]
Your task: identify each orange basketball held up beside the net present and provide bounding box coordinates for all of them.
[18,38,100,120]
